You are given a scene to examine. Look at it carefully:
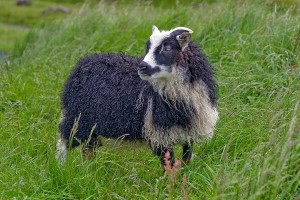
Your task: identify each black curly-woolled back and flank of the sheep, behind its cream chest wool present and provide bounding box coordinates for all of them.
[60,54,147,145]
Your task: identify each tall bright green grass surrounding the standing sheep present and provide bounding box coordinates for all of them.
[0,0,300,200]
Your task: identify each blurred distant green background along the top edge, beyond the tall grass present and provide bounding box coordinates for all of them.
[0,0,300,54]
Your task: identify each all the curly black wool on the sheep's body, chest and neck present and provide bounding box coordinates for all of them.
[59,43,216,147]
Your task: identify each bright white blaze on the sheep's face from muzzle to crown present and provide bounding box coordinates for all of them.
[143,26,193,69]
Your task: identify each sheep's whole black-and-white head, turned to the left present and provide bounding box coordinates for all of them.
[138,26,193,80]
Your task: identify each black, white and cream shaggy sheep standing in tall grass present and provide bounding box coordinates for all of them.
[56,26,218,166]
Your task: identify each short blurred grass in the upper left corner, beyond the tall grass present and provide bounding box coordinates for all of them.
[0,0,80,52]
